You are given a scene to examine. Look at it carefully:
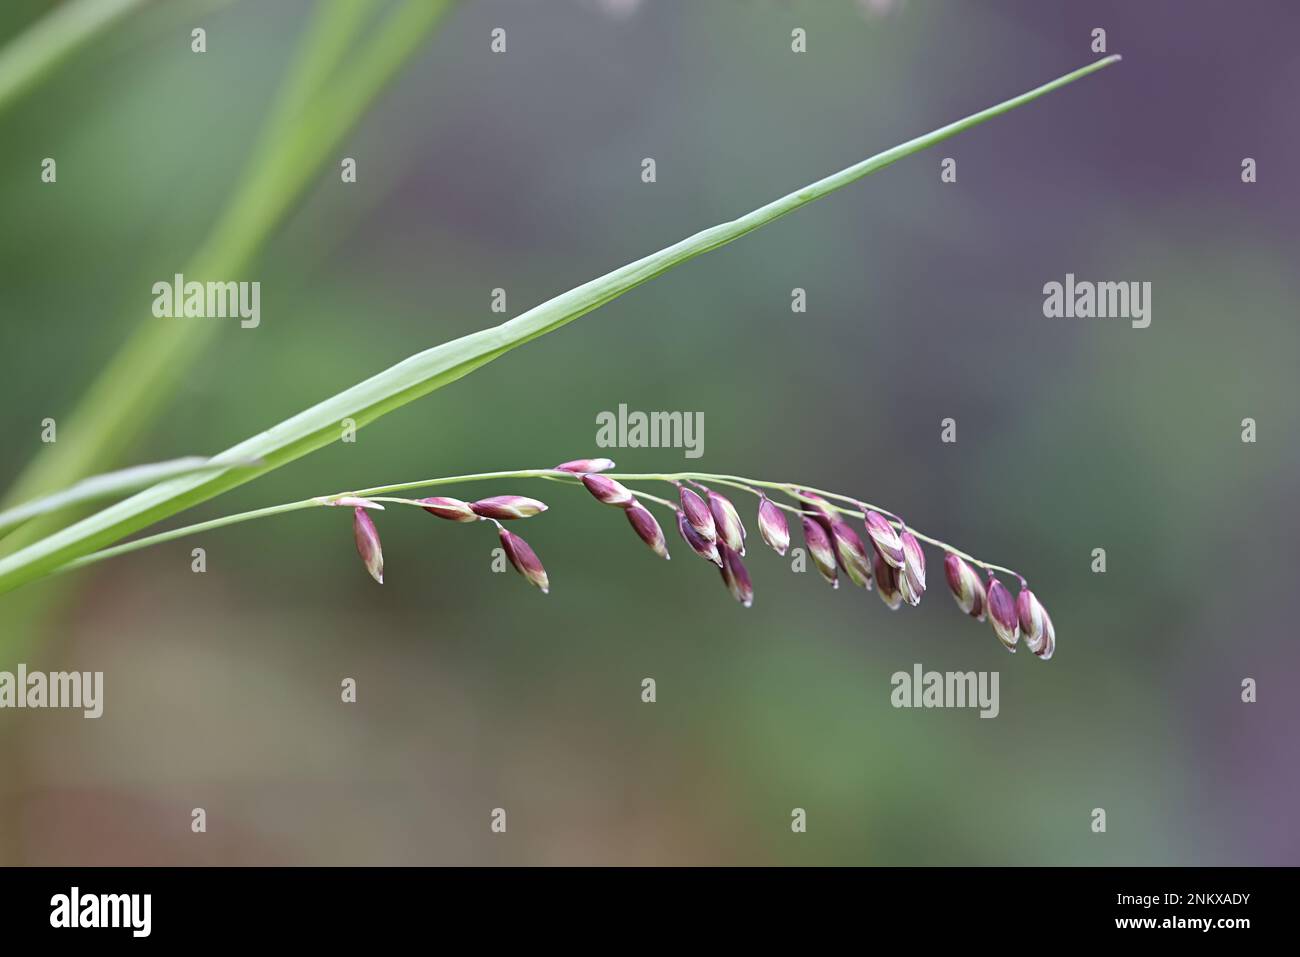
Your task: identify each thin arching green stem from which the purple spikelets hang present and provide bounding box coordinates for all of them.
[57,468,1021,577]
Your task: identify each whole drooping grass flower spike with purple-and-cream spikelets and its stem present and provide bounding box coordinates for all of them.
[60,459,1056,661]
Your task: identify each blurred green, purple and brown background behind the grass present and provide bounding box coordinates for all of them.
[0,0,1300,865]
